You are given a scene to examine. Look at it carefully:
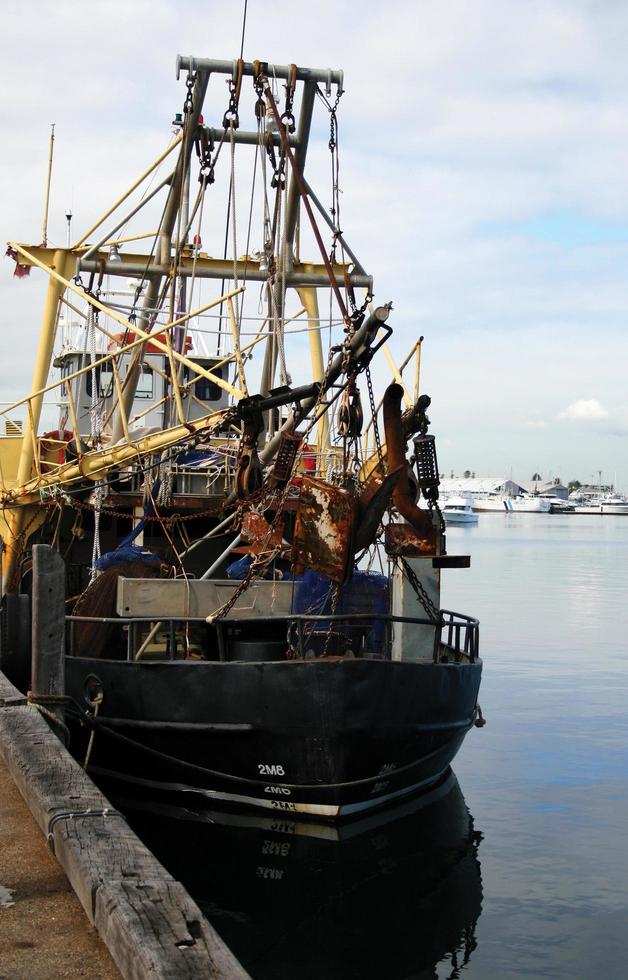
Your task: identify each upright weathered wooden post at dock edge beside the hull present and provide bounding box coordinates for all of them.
[31,544,65,720]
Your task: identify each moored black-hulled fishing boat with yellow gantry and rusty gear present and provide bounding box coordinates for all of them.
[0,57,483,820]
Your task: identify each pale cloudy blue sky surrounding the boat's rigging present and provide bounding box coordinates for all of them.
[0,0,628,490]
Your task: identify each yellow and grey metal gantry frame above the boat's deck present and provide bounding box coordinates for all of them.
[0,56,373,576]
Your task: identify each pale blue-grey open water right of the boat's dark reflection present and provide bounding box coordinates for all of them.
[437,514,628,978]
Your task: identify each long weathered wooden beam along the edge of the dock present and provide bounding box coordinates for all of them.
[0,673,248,980]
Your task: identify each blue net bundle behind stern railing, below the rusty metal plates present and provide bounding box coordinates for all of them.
[292,569,389,656]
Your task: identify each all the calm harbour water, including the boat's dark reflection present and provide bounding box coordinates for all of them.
[120,514,628,980]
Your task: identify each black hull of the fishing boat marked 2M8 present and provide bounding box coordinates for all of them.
[66,657,482,819]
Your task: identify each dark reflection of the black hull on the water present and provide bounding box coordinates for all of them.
[116,771,482,980]
